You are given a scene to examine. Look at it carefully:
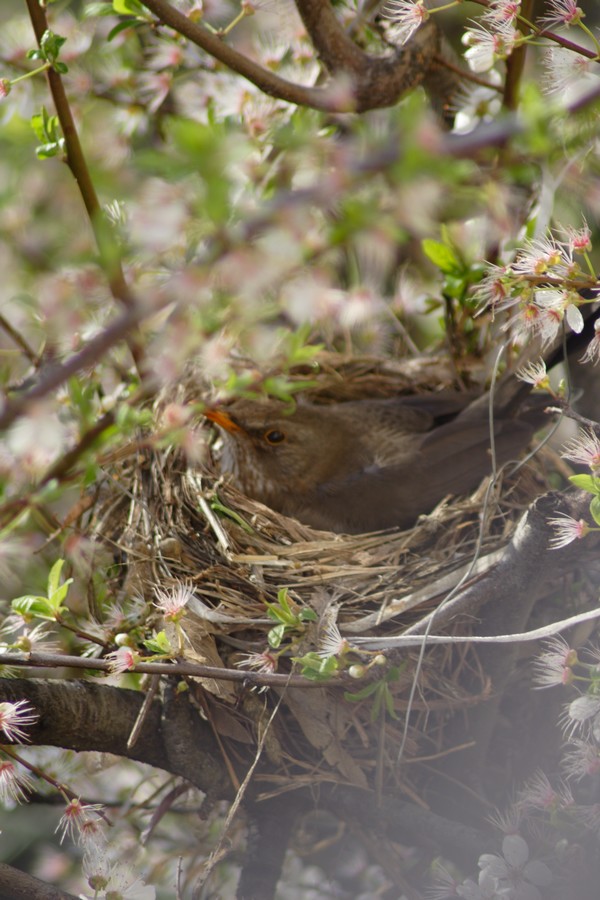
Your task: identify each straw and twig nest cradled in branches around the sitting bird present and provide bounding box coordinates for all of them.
[93,355,544,799]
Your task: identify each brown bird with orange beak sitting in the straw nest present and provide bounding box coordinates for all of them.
[204,376,547,533]
